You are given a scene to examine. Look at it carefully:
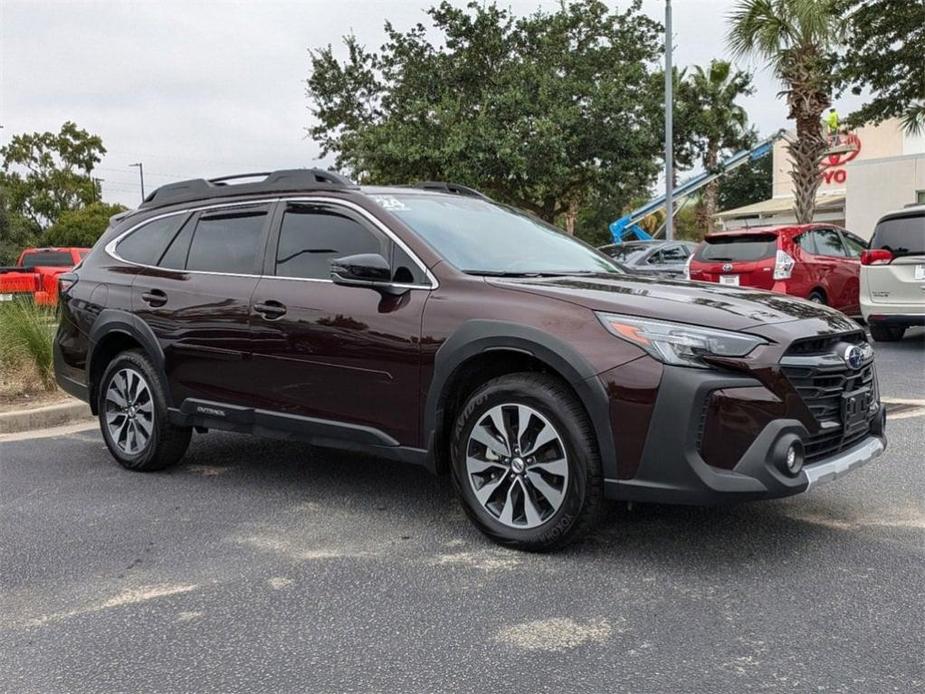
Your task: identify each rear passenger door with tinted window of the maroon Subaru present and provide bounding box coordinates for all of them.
[131,204,270,405]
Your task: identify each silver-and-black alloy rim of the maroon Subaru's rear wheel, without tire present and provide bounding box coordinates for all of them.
[105,368,154,455]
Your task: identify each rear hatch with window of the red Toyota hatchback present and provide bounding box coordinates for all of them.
[690,232,777,290]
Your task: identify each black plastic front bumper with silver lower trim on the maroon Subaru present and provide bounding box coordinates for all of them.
[605,367,887,505]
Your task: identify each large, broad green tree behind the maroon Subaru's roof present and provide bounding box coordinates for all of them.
[308,0,661,231]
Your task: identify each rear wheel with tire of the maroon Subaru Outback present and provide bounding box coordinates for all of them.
[97,351,192,472]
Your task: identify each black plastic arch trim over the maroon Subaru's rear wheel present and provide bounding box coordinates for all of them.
[87,309,173,414]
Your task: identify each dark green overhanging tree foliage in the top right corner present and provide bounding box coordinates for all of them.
[839,0,925,132]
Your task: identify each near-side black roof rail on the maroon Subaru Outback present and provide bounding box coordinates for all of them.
[139,169,359,209]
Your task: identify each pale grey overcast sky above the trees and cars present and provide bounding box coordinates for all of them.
[0,0,868,206]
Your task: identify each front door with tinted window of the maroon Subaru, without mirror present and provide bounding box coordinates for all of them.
[251,202,430,446]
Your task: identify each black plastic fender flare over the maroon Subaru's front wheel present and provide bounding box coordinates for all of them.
[422,319,617,478]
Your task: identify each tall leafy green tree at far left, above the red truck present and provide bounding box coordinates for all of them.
[0,121,106,229]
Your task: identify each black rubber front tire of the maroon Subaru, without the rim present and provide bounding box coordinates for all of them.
[451,373,604,551]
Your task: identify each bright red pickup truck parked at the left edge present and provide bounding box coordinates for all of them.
[0,248,90,306]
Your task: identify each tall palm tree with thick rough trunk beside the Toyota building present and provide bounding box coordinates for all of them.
[727,0,842,224]
